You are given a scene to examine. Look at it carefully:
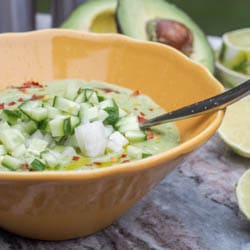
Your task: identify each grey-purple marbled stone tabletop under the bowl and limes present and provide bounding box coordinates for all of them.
[0,136,250,250]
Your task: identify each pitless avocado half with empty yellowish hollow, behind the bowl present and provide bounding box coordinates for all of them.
[61,0,117,33]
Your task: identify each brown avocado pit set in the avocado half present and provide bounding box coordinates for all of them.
[146,18,193,56]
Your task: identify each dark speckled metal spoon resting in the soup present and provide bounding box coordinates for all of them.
[140,79,250,129]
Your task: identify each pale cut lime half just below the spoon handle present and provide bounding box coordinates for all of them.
[218,96,250,158]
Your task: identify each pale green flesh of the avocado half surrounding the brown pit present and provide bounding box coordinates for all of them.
[116,0,214,72]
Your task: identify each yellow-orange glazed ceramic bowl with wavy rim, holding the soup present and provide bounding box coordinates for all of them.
[0,30,223,240]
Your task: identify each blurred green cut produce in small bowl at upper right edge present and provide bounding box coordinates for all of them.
[219,28,250,75]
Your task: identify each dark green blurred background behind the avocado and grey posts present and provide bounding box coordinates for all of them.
[37,0,250,36]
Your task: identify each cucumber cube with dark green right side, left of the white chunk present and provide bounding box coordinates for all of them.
[49,117,71,137]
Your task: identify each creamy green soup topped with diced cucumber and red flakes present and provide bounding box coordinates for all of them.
[0,80,179,171]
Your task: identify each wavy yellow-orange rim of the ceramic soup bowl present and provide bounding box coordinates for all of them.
[0,29,224,181]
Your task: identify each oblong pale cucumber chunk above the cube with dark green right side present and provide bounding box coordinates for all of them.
[53,96,80,115]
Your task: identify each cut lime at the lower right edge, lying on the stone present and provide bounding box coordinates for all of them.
[236,169,250,220]
